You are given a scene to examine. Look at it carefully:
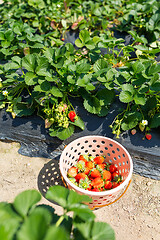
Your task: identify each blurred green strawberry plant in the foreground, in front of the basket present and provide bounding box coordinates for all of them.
[0,186,115,240]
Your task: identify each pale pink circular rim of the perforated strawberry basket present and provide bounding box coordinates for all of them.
[59,135,133,197]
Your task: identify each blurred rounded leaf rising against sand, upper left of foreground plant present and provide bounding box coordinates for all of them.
[13,190,41,217]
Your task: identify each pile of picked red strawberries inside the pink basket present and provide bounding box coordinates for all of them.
[67,155,122,192]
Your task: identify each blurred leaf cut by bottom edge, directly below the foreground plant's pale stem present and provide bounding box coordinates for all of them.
[44,226,70,240]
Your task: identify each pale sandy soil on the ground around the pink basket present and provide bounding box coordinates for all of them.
[0,141,160,240]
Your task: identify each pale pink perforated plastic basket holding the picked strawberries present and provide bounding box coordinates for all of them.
[59,136,133,209]
